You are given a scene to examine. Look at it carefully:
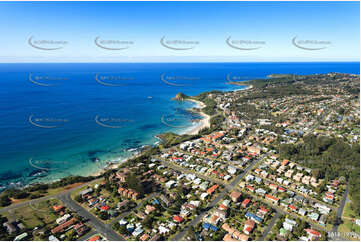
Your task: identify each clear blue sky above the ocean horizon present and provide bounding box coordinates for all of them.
[0,2,360,62]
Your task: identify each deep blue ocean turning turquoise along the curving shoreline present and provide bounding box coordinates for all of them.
[0,62,360,186]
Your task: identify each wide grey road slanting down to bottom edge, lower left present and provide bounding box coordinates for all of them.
[58,193,125,241]
